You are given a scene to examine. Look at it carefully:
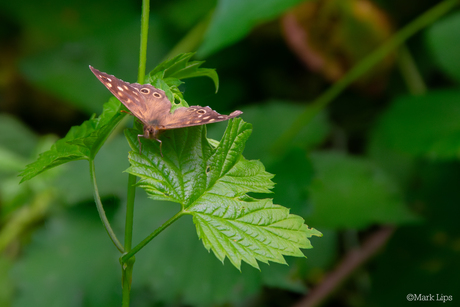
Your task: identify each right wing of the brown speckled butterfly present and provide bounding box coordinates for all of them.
[159,106,243,130]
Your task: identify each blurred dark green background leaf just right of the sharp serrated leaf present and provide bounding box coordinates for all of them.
[308,152,417,229]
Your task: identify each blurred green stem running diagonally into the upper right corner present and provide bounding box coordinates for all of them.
[271,0,458,154]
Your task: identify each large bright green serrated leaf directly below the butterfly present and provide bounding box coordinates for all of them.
[126,118,321,269]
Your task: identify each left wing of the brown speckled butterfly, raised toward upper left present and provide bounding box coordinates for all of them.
[89,66,171,125]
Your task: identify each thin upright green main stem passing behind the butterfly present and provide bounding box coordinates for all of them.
[120,0,150,307]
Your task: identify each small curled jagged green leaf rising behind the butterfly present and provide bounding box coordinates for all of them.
[148,52,219,92]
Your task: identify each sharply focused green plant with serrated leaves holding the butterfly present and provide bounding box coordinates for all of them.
[17,1,322,306]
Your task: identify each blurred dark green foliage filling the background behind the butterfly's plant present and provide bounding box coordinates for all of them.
[0,0,460,306]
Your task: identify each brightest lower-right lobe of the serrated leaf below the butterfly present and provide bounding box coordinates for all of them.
[190,193,321,269]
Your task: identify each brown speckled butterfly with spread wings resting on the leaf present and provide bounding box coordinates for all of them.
[89,65,243,156]
